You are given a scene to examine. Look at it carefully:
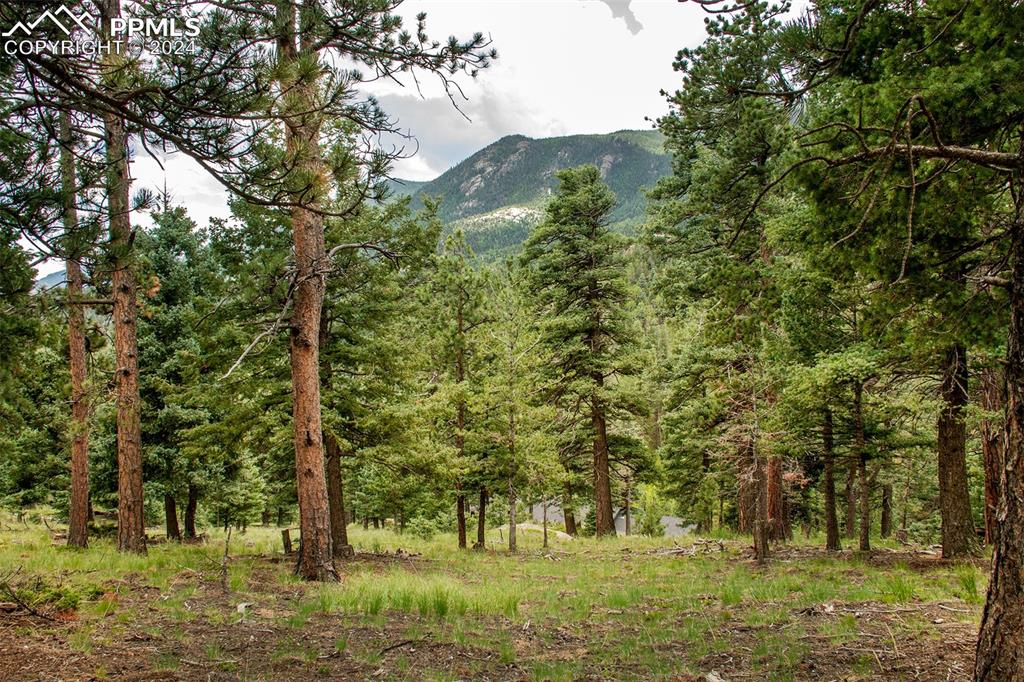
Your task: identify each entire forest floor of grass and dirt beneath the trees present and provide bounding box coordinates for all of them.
[0,516,987,682]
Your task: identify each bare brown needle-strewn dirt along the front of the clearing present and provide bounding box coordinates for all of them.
[0,549,977,682]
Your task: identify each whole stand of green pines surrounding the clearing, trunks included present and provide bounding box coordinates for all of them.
[0,0,1024,680]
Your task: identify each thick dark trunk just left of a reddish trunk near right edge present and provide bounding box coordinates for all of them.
[938,343,979,559]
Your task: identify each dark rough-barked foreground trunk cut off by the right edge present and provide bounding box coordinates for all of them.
[974,216,1024,682]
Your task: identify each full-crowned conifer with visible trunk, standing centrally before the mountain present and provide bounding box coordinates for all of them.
[523,166,632,537]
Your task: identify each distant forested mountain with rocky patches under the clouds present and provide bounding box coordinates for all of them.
[391,130,671,258]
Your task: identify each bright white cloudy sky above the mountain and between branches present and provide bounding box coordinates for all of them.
[41,0,706,273]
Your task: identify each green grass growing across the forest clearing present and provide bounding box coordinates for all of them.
[0,507,985,680]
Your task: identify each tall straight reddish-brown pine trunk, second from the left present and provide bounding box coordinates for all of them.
[99,0,145,554]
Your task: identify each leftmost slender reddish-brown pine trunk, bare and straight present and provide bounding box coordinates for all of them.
[60,112,89,548]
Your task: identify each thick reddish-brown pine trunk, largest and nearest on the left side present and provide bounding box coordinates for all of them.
[279,2,338,581]
